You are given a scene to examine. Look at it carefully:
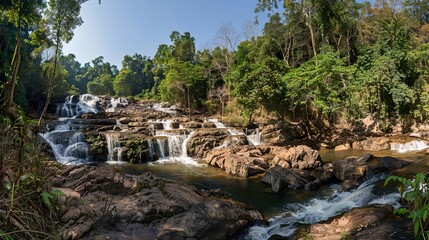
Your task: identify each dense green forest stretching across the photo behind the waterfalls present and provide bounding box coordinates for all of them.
[0,0,429,130]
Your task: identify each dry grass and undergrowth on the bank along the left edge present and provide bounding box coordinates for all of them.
[0,123,61,239]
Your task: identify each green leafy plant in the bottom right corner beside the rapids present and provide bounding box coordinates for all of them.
[384,173,429,240]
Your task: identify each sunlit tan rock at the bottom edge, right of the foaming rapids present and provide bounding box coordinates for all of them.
[302,204,393,240]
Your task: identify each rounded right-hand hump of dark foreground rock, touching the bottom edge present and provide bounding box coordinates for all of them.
[158,200,263,240]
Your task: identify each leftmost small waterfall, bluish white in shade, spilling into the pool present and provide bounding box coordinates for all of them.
[41,123,90,164]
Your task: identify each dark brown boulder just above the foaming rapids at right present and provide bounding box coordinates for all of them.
[333,154,408,190]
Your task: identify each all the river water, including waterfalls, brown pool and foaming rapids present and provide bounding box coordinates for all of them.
[43,94,429,240]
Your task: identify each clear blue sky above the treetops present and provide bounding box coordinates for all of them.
[63,0,267,68]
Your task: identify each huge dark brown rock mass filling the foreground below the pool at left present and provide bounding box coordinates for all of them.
[52,165,263,239]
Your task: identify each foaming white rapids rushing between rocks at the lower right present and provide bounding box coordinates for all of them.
[241,177,400,240]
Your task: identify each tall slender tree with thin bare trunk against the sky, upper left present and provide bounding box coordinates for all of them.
[39,0,82,125]
